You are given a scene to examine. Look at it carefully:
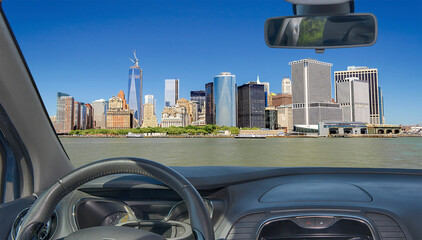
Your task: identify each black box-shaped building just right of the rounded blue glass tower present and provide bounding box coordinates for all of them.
[237,82,266,128]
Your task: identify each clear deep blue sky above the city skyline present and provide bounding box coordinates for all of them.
[3,0,422,124]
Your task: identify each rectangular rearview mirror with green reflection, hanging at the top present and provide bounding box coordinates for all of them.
[265,13,378,49]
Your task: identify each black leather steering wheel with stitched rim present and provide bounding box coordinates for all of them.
[16,157,214,240]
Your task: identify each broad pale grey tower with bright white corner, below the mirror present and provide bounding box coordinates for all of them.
[290,59,343,125]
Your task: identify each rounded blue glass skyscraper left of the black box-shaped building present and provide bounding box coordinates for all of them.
[214,72,236,127]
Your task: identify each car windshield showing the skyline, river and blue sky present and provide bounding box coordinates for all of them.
[3,0,422,169]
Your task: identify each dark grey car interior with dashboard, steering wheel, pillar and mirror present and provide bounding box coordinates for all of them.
[0,0,422,240]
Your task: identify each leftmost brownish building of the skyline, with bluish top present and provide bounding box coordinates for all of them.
[54,92,75,133]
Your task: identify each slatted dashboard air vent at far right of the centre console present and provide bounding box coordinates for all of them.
[366,212,406,240]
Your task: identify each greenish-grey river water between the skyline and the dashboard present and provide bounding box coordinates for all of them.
[60,137,422,169]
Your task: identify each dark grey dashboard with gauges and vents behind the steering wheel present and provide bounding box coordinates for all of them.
[12,167,422,240]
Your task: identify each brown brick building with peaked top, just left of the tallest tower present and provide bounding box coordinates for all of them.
[107,91,134,129]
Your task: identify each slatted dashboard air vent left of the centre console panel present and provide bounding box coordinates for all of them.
[227,213,265,240]
